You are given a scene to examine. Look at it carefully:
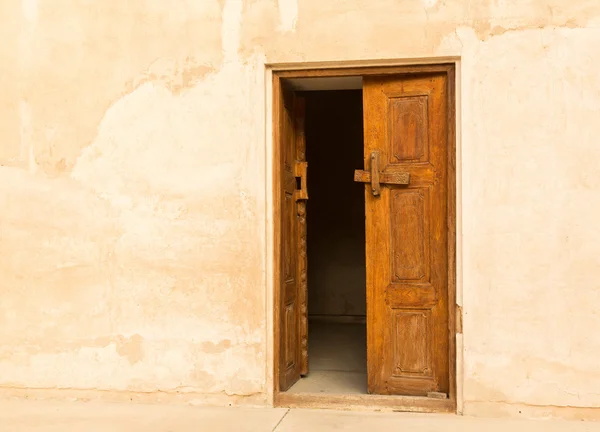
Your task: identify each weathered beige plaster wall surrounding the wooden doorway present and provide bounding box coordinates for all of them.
[0,0,600,417]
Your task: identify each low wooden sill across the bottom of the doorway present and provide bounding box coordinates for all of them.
[274,392,456,413]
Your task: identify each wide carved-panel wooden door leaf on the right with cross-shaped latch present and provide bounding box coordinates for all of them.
[355,74,450,397]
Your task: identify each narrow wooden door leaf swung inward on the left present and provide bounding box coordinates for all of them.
[279,89,308,391]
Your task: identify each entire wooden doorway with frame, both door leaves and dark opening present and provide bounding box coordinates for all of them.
[273,65,456,412]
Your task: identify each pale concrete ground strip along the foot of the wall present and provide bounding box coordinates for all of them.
[0,401,600,432]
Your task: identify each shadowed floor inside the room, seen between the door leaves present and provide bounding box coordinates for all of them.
[288,322,367,394]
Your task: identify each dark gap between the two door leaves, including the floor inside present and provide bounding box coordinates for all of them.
[289,90,367,394]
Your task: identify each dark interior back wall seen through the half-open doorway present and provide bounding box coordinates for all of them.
[304,90,366,316]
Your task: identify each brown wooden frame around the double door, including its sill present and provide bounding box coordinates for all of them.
[271,62,454,412]
